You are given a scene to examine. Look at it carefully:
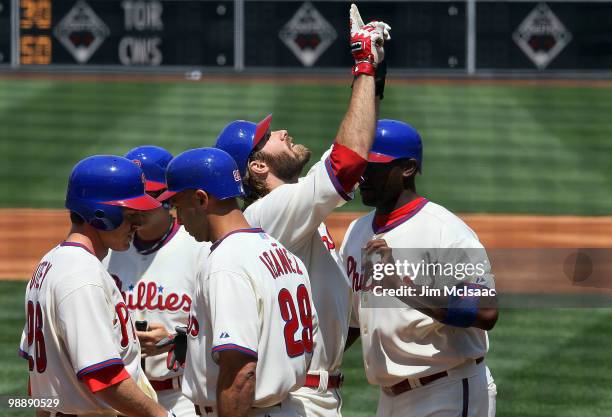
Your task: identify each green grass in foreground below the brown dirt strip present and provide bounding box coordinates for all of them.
[0,282,612,417]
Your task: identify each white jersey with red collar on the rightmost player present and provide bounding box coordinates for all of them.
[340,197,494,386]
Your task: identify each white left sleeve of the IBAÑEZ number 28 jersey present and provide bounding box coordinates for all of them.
[209,271,260,361]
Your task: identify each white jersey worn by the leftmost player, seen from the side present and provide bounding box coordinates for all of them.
[20,242,141,414]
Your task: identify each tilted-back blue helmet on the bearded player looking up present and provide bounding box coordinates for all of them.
[215,114,272,177]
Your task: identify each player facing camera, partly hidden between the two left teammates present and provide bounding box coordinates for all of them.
[103,146,210,417]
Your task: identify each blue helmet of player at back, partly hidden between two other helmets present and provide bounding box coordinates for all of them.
[125,146,172,191]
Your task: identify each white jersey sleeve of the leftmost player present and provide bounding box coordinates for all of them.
[57,284,125,378]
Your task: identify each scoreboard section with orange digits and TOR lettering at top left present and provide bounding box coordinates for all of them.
[13,0,234,67]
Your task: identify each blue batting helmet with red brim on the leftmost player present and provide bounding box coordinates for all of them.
[65,155,160,231]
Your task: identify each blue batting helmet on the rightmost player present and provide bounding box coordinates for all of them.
[368,119,423,170]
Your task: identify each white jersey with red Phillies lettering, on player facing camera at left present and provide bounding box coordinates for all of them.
[102,223,210,381]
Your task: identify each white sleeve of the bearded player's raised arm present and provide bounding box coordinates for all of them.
[245,158,350,249]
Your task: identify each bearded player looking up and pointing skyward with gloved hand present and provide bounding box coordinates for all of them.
[215,5,390,417]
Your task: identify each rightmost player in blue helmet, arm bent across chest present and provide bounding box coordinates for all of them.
[340,120,498,417]
